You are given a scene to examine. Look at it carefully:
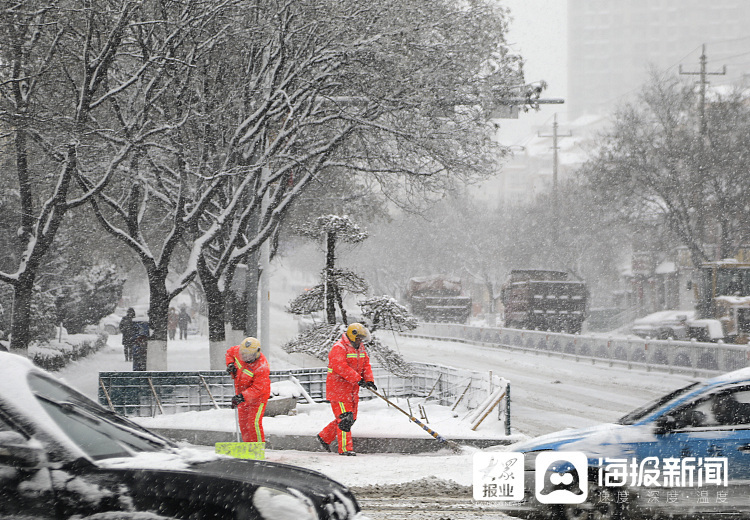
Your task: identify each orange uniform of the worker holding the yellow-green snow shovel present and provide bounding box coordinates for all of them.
[226,345,271,442]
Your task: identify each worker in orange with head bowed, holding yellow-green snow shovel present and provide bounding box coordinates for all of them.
[226,338,271,442]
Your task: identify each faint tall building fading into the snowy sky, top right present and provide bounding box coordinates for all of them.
[567,0,750,120]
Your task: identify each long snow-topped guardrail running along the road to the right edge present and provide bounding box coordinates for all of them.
[404,323,750,375]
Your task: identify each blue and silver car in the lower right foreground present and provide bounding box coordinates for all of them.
[506,368,750,519]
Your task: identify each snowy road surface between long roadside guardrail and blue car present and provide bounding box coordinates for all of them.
[386,337,694,436]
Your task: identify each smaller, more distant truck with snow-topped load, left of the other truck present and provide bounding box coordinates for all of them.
[406,275,471,323]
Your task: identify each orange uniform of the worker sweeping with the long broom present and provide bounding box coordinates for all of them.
[319,334,374,453]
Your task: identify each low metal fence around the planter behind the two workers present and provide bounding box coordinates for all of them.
[99,363,510,434]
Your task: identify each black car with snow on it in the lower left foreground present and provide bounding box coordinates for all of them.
[0,352,359,520]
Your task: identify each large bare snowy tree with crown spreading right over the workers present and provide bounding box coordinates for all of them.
[191,0,536,368]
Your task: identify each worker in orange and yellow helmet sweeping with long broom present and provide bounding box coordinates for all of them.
[318,323,378,456]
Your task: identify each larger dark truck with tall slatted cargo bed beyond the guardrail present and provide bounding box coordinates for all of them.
[502,269,588,333]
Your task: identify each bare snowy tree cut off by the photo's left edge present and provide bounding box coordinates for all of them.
[0,0,153,355]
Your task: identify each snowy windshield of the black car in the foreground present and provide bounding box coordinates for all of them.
[29,373,171,460]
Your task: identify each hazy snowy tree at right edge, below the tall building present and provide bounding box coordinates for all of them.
[582,75,750,265]
